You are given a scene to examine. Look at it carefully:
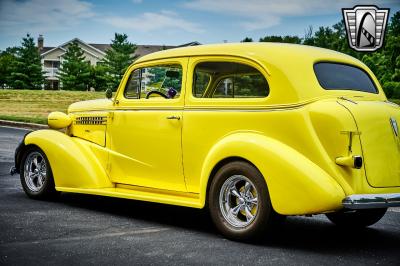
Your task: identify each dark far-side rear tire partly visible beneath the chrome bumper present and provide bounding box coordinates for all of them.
[326,208,387,228]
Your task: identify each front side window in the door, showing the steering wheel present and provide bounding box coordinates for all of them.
[124,65,182,99]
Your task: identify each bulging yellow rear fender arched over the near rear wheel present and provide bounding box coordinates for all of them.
[200,132,345,215]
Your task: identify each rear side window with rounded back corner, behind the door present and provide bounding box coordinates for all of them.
[193,62,269,98]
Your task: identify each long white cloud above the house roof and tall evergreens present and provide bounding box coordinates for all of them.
[101,10,203,33]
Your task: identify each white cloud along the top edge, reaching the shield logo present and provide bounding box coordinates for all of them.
[184,0,398,30]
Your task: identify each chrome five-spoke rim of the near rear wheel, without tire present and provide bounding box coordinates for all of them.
[219,175,258,228]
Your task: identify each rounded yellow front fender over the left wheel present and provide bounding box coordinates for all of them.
[24,129,113,188]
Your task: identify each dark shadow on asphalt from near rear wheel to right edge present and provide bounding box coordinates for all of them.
[262,213,400,252]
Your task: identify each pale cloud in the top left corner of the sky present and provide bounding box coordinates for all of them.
[0,0,95,35]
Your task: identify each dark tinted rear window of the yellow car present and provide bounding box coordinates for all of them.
[314,63,378,93]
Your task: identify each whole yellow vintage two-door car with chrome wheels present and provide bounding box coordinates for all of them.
[12,43,400,239]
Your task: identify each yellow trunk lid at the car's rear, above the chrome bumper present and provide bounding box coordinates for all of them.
[340,98,400,187]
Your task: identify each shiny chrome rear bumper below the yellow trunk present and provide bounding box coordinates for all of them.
[342,193,400,210]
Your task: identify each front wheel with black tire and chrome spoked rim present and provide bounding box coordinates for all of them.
[20,147,58,199]
